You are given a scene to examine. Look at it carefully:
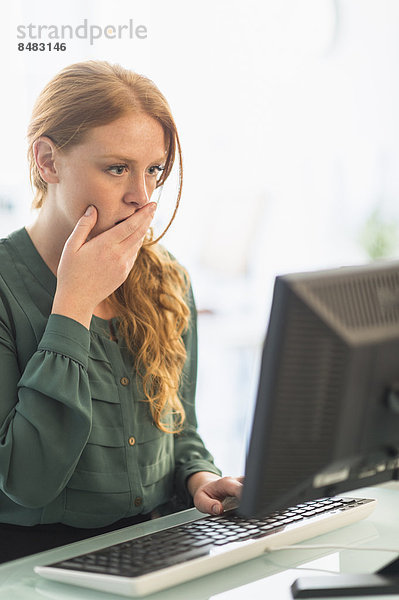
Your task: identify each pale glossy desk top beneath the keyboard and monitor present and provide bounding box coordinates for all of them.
[0,483,399,600]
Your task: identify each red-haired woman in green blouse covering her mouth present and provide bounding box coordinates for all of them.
[0,61,241,561]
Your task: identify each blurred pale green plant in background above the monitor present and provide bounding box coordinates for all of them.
[359,208,398,260]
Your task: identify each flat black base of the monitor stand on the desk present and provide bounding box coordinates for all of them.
[291,558,399,598]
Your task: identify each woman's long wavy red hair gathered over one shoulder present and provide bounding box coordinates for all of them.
[28,60,190,433]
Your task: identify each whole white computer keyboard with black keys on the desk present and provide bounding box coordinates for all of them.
[35,498,376,597]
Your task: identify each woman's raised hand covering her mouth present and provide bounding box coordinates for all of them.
[51,202,157,329]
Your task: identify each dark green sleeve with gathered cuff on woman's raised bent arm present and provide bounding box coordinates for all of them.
[0,307,91,508]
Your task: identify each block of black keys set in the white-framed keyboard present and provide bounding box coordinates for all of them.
[49,498,370,577]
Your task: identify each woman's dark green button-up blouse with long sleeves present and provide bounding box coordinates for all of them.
[0,229,220,527]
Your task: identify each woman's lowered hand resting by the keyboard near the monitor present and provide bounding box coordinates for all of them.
[188,471,244,515]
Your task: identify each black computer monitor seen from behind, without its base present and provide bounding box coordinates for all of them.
[239,262,399,516]
